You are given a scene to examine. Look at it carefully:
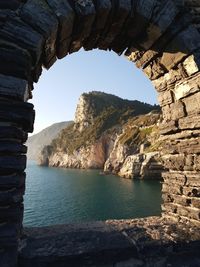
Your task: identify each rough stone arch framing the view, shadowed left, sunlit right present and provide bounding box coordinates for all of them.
[0,0,200,266]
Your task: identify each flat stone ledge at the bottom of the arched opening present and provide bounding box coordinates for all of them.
[19,217,200,267]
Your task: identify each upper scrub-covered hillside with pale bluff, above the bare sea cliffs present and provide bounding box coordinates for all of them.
[51,92,159,154]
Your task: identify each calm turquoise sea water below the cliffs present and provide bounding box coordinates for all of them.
[24,161,161,226]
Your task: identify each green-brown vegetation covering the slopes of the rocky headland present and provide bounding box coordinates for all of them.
[43,92,160,158]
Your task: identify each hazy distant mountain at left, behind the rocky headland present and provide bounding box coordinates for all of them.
[26,121,72,160]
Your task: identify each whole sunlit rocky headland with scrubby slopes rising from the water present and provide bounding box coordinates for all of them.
[40,92,162,178]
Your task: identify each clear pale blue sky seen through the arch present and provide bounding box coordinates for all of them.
[30,50,157,133]
